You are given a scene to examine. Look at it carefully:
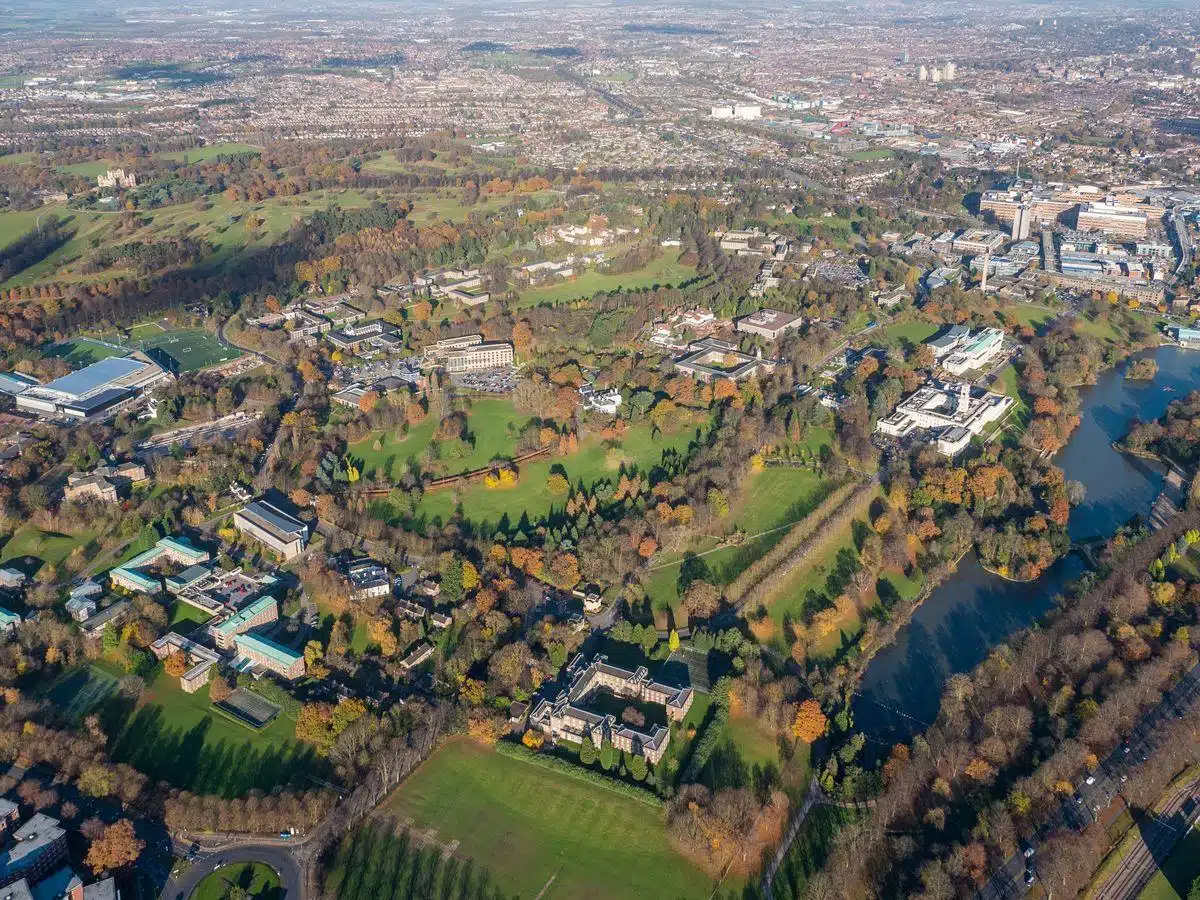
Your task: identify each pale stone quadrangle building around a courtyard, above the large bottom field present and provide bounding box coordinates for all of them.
[529,654,694,764]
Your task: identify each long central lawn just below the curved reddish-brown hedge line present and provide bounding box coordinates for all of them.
[408,422,697,530]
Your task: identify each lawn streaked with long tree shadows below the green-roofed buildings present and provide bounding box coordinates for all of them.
[91,668,324,797]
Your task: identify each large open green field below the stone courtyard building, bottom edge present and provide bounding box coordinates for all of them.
[383,740,710,900]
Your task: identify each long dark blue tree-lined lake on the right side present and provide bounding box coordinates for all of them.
[853,347,1200,755]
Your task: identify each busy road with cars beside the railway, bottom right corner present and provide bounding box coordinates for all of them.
[977,665,1200,900]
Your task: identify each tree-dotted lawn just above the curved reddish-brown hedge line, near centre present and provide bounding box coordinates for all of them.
[349,397,528,479]
